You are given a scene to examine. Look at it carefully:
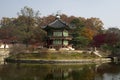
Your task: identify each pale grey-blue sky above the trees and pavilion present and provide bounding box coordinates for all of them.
[0,0,120,28]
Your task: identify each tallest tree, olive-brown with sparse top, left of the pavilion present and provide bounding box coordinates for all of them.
[15,6,42,46]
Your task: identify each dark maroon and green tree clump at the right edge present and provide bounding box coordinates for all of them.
[93,28,120,54]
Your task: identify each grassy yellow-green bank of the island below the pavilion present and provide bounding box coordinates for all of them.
[9,53,99,60]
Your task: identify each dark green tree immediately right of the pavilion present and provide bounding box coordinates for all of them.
[71,18,89,48]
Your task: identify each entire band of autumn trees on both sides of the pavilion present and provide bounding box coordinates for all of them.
[0,6,120,50]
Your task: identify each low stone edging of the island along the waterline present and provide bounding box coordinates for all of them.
[5,58,111,64]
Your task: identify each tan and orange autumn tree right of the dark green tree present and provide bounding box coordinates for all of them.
[82,18,103,40]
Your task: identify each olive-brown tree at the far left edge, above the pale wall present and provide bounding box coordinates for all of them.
[0,17,15,42]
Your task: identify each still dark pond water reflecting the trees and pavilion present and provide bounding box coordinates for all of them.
[0,63,120,80]
